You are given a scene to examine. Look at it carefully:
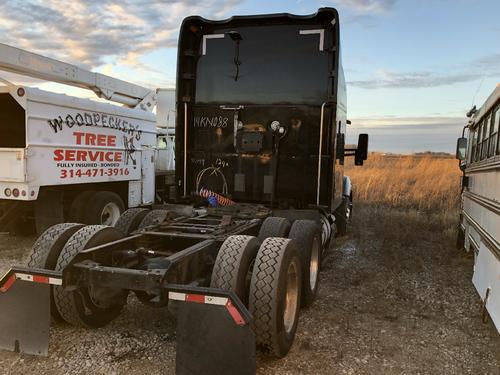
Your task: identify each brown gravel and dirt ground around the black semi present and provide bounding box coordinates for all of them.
[0,206,500,375]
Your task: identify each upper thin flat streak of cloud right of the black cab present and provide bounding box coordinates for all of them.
[348,54,500,89]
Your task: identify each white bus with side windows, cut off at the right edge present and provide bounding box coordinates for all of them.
[457,84,500,332]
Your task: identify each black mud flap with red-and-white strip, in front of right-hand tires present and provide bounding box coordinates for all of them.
[168,285,256,375]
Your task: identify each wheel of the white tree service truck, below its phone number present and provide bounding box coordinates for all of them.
[83,191,125,226]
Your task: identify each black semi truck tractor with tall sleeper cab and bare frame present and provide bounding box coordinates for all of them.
[0,8,368,374]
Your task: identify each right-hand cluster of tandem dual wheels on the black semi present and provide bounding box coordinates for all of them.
[211,217,321,357]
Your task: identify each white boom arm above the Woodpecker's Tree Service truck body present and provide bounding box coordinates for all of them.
[0,43,156,111]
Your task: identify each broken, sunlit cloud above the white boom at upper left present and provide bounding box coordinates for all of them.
[0,0,240,69]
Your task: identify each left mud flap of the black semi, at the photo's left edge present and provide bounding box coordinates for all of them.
[0,268,61,356]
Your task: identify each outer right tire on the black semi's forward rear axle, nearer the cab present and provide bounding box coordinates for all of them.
[288,220,322,307]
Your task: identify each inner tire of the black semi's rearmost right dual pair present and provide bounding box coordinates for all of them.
[210,235,260,306]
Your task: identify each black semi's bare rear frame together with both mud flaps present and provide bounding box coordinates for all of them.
[0,215,282,374]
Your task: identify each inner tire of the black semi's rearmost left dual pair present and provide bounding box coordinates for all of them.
[53,225,125,328]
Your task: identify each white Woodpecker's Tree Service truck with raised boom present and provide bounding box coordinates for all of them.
[0,44,174,233]
